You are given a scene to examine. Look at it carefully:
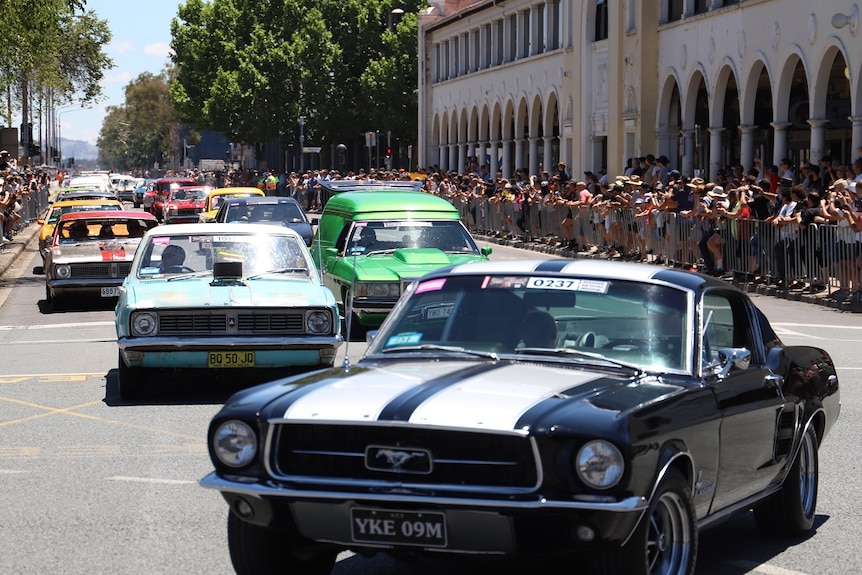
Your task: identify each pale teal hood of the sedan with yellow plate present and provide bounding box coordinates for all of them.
[126,275,334,309]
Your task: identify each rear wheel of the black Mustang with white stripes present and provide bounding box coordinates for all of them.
[754,427,820,535]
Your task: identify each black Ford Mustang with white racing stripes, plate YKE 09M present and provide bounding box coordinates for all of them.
[204,260,840,575]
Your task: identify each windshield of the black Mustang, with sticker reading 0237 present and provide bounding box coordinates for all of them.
[368,275,692,372]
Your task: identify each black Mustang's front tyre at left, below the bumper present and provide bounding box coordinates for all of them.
[227,511,335,575]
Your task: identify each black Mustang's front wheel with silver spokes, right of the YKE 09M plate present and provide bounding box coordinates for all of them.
[597,469,698,575]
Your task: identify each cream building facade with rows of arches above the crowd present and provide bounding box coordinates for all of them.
[417,0,862,178]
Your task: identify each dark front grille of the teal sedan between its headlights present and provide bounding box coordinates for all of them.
[159,310,312,335]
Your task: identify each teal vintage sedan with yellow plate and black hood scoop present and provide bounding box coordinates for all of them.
[116,223,343,399]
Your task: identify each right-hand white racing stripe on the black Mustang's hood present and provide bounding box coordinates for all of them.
[410,364,596,431]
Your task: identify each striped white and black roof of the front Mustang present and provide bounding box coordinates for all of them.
[426,259,724,290]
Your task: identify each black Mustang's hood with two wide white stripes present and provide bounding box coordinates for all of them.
[230,360,683,433]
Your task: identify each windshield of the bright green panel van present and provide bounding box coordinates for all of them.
[345,221,478,255]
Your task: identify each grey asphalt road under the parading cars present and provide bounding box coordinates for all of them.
[0,235,862,575]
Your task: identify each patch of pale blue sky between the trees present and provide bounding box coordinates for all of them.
[58,0,185,145]
